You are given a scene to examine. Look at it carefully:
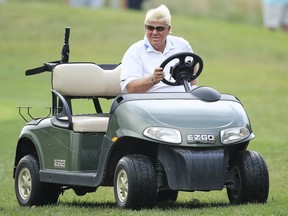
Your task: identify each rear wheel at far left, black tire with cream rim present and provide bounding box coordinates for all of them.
[14,155,60,206]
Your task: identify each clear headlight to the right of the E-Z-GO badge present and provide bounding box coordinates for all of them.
[220,127,250,144]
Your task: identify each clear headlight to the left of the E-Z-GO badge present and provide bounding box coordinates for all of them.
[143,127,182,144]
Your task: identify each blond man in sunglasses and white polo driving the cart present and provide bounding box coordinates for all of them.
[120,5,197,93]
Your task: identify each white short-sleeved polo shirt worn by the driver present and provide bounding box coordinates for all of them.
[120,35,193,92]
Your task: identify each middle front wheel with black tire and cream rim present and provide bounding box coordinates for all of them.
[114,155,157,210]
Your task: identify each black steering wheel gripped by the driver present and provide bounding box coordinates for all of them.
[160,52,203,86]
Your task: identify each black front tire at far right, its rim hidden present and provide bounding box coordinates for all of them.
[227,151,269,204]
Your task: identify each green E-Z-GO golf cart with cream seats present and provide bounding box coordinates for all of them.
[13,28,269,209]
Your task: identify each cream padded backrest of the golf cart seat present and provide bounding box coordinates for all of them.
[52,63,122,97]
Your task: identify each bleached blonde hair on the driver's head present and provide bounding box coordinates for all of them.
[144,5,171,26]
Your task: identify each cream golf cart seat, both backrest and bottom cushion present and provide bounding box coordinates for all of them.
[52,63,122,132]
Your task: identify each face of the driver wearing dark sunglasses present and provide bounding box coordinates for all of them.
[145,22,171,52]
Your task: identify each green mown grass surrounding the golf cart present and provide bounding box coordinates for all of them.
[0,0,288,216]
